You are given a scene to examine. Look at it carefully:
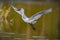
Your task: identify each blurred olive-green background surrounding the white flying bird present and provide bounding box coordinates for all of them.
[0,0,60,40]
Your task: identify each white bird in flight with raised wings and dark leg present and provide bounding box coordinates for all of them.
[12,6,52,30]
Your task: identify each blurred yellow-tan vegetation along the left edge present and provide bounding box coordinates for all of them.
[0,3,12,30]
